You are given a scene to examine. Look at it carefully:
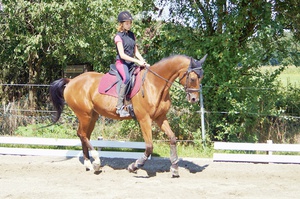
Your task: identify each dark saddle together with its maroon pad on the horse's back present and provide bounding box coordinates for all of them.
[98,64,142,101]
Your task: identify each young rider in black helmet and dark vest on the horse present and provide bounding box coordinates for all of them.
[114,11,149,117]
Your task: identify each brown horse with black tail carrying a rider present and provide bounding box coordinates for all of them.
[50,55,207,177]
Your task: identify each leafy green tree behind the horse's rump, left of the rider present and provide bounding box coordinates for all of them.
[0,0,152,108]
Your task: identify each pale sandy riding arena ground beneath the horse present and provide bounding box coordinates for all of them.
[0,155,300,199]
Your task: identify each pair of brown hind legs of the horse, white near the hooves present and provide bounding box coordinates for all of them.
[77,112,101,171]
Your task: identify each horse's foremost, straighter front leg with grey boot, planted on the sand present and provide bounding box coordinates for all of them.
[155,116,179,178]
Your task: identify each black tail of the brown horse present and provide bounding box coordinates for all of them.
[50,78,70,123]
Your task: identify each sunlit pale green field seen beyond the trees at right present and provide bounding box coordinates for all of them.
[261,66,300,88]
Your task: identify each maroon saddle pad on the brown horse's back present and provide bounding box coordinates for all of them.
[98,73,142,99]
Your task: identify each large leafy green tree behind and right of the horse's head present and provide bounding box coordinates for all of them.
[149,0,299,141]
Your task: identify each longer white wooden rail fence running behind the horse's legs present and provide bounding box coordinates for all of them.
[0,137,145,159]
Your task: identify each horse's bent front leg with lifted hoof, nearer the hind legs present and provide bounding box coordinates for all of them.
[128,119,153,173]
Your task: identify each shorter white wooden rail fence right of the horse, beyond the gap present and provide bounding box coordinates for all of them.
[213,140,300,164]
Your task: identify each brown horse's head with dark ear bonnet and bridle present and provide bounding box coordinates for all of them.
[180,55,207,103]
